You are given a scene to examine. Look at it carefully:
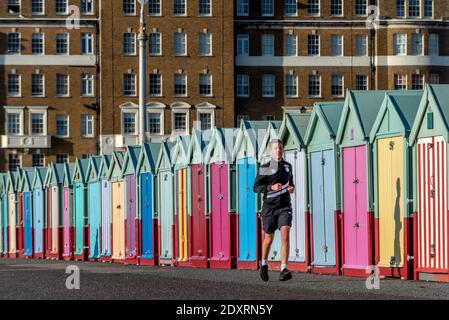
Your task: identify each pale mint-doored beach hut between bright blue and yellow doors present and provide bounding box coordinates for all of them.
[156,142,176,265]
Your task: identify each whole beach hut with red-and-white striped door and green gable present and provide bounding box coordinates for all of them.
[409,85,449,281]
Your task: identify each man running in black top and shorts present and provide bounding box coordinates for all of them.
[254,139,295,281]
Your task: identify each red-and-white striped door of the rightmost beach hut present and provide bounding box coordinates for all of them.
[417,136,448,273]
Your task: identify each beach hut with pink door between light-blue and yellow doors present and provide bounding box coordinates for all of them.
[336,90,385,276]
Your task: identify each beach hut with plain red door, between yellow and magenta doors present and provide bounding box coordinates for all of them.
[187,129,212,268]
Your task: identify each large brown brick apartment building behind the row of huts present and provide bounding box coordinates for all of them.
[0,0,449,171]
